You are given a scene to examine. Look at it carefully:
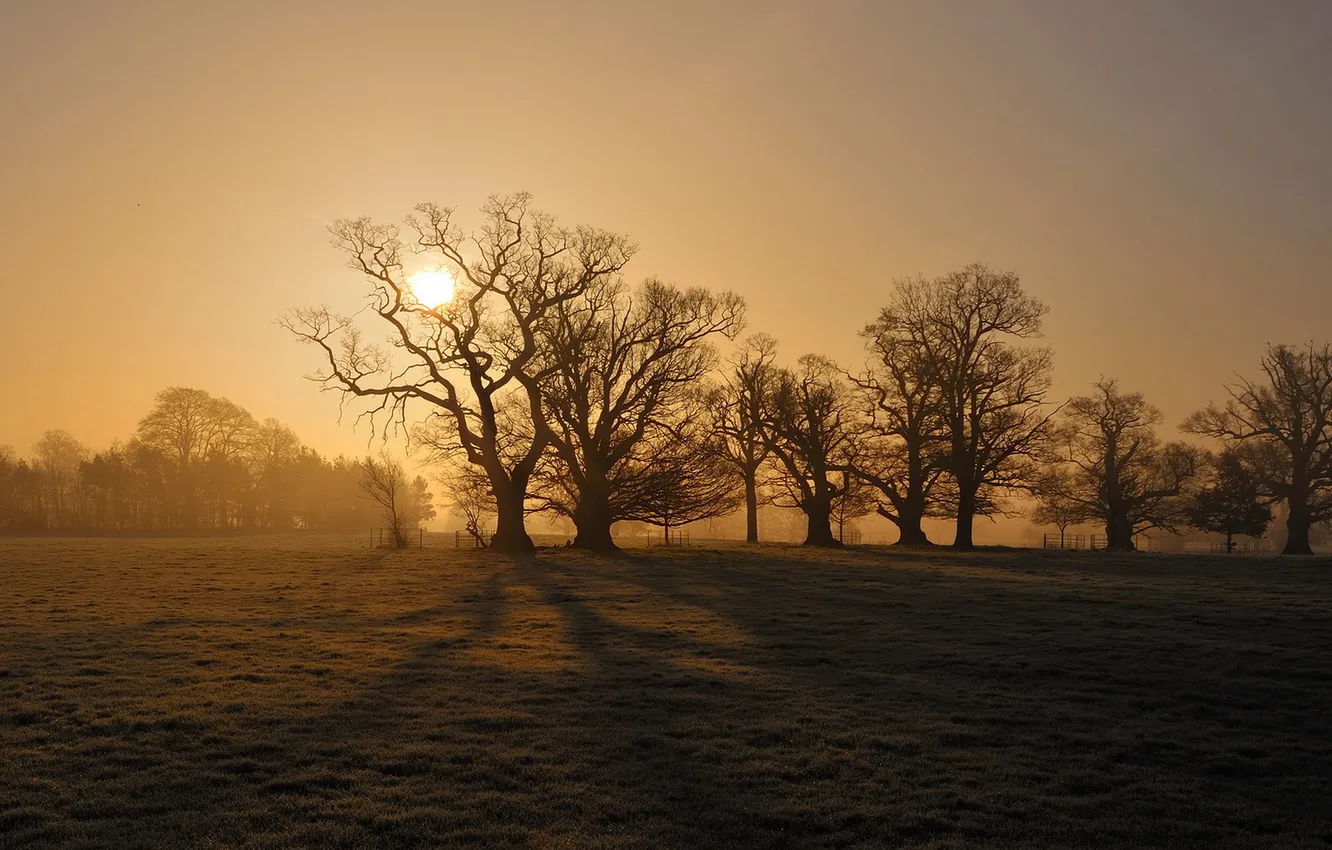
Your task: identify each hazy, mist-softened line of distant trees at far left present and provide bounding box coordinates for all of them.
[0,386,433,530]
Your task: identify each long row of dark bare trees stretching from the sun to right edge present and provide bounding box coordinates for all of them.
[282,195,1332,552]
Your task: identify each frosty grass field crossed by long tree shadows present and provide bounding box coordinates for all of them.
[0,537,1332,847]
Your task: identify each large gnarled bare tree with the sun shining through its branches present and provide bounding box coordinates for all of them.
[282,195,634,552]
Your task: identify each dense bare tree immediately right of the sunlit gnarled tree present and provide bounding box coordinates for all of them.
[542,280,745,549]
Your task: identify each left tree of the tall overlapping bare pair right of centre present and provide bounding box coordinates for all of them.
[851,298,956,546]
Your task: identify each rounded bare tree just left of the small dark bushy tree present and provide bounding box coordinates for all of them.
[1042,378,1203,552]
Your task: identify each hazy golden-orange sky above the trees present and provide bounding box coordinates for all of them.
[0,0,1332,522]
